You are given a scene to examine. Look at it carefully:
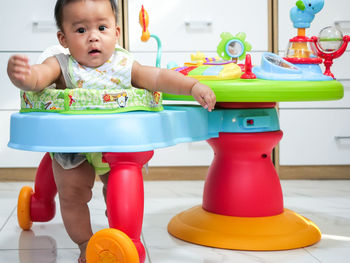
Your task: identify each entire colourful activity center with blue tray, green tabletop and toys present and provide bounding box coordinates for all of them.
[8,0,349,263]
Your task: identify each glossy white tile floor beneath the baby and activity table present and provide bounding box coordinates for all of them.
[0,180,350,263]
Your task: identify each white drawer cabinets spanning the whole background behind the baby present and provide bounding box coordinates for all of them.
[0,0,350,167]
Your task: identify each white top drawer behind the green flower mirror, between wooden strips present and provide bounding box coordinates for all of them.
[128,0,268,52]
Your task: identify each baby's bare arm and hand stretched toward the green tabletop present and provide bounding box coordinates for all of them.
[131,62,216,111]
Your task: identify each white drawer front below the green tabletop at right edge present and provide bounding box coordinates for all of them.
[279,109,350,165]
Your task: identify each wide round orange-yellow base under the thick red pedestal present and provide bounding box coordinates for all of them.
[168,206,321,251]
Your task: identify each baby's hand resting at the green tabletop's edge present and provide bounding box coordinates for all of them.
[191,82,216,111]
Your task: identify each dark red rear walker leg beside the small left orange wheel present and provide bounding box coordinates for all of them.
[30,153,57,222]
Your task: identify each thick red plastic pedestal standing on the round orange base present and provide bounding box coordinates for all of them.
[203,131,283,217]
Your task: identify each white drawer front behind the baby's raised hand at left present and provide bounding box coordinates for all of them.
[0,52,41,110]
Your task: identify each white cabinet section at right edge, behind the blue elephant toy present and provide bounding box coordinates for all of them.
[278,0,350,165]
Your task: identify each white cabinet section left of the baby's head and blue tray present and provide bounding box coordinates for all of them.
[0,0,57,168]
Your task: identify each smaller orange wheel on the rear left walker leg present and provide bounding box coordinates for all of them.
[17,186,33,230]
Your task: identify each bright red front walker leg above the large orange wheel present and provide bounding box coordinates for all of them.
[103,151,153,263]
